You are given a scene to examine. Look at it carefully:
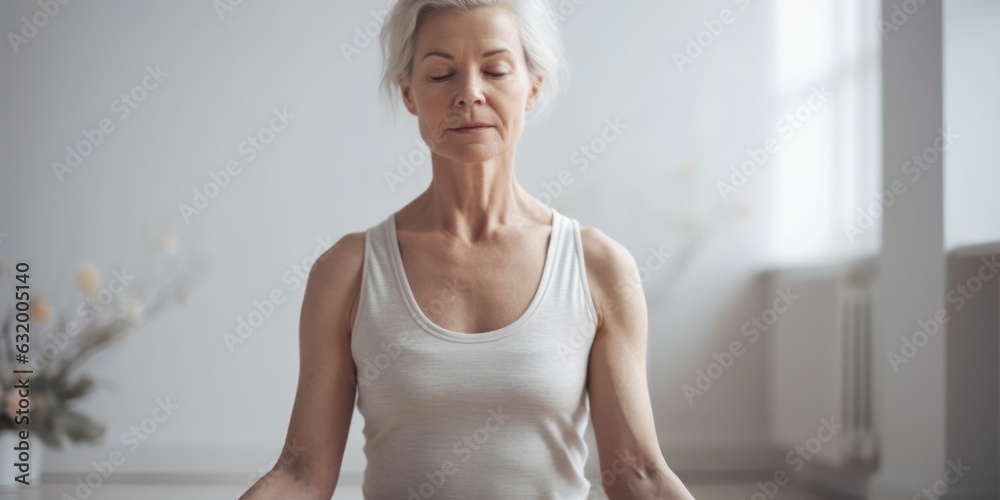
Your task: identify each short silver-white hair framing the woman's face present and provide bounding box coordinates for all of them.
[379,0,566,119]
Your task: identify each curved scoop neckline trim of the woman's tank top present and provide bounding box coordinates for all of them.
[388,207,563,343]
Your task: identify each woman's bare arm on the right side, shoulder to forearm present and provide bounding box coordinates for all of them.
[581,228,694,500]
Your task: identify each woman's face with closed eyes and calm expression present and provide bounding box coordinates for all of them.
[400,7,541,164]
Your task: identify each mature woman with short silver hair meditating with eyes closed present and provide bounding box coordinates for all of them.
[243,0,693,500]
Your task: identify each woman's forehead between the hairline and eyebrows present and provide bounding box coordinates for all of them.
[416,7,521,55]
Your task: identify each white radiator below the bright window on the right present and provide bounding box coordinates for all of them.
[765,260,877,468]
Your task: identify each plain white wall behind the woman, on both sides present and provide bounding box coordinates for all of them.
[0,0,848,484]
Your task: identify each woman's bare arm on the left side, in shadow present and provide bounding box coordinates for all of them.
[240,233,365,500]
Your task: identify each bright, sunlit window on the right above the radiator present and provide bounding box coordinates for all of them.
[770,0,882,263]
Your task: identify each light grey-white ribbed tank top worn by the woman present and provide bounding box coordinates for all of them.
[351,209,597,500]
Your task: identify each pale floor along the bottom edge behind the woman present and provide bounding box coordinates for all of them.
[0,484,826,500]
